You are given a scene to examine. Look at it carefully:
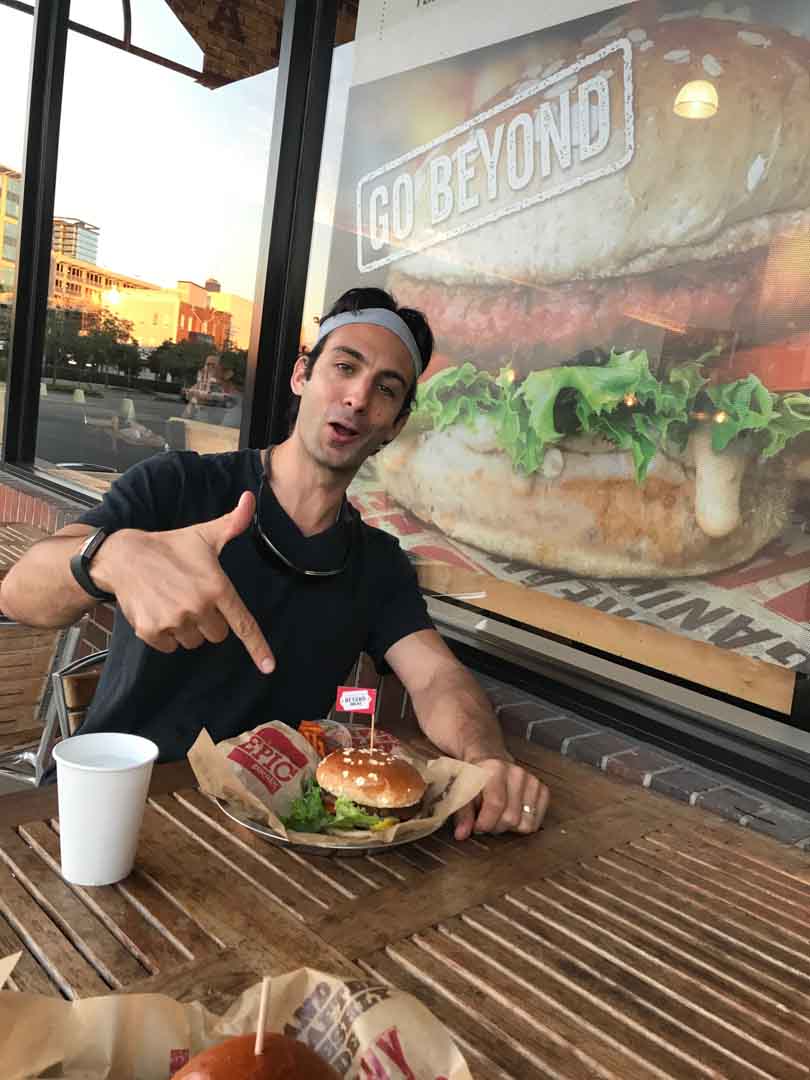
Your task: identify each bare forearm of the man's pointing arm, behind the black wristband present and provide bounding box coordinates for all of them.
[0,530,98,626]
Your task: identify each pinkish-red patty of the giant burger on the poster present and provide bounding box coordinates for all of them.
[389,251,767,375]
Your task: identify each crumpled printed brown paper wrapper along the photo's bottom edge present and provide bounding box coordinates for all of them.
[0,954,472,1080]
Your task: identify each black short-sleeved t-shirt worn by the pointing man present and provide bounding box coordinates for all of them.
[80,450,433,761]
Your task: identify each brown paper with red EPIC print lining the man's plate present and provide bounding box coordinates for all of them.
[188,721,486,849]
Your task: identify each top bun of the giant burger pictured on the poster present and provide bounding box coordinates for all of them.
[391,13,810,332]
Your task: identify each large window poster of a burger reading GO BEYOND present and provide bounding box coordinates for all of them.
[326,0,810,685]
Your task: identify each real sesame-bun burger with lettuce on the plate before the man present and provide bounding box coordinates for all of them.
[283,750,427,833]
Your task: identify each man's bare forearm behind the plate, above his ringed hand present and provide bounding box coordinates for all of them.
[411,665,511,761]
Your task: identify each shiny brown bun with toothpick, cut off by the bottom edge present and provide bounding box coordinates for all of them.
[172,1032,339,1080]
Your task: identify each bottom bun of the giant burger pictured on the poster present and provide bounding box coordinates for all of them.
[376,426,795,578]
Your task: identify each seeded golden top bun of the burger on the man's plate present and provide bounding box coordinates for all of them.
[315,750,427,810]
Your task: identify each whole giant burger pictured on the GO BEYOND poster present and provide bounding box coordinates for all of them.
[376,12,810,578]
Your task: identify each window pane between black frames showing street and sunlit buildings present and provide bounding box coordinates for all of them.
[30,0,278,490]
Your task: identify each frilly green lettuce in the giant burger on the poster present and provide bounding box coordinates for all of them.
[414,349,810,483]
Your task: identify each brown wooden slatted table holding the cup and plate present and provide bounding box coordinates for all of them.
[0,741,810,1080]
